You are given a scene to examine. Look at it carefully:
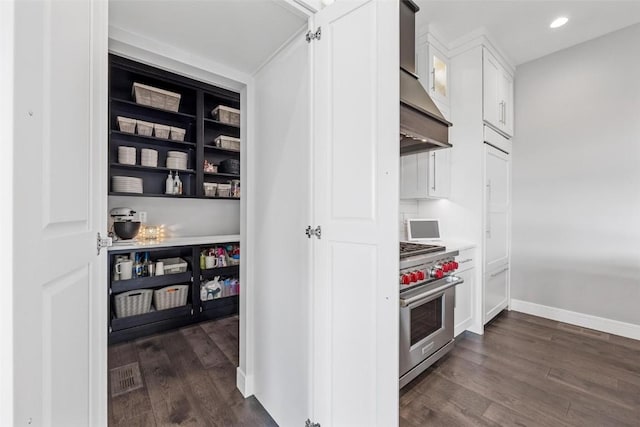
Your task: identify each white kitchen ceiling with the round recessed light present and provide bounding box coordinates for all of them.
[415,0,640,65]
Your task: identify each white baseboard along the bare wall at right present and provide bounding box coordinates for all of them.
[511,299,640,340]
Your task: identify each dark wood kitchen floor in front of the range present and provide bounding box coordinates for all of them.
[400,312,640,427]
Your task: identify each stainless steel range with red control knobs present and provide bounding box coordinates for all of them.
[400,242,463,388]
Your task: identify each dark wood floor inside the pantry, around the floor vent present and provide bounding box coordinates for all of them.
[109,316,276,427]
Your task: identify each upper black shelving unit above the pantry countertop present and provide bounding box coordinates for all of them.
[109,55,240,200]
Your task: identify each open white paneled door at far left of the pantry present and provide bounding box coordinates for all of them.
[14,0,107,427]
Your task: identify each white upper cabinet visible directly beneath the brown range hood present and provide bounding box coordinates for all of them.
[400,148,451,199]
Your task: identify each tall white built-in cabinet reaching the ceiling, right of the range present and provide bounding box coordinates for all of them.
[449,36,514,332]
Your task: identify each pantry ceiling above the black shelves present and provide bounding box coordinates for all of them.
[109,0,307,74]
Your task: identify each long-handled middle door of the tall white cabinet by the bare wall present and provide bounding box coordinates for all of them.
[484,144,511,271]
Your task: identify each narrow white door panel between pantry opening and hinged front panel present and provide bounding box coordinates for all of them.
[248,30,313,426]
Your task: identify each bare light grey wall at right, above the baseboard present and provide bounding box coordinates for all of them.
[511,25,640,325]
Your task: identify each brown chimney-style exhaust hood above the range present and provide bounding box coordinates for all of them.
[400,0,451,156]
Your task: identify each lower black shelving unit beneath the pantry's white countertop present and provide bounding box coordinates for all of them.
[108,242,240,344]
